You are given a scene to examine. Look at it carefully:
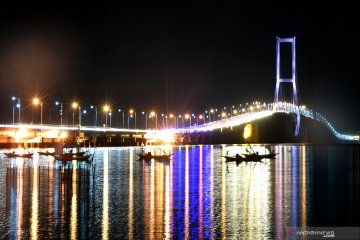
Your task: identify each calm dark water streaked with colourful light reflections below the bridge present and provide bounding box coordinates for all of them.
[0,145,360,239]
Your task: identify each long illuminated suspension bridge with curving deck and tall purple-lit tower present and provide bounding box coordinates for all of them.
[0,37,359,143]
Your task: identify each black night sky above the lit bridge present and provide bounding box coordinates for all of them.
[0,5,360,132]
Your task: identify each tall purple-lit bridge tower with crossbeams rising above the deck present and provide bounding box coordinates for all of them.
[274,37,300,136]
